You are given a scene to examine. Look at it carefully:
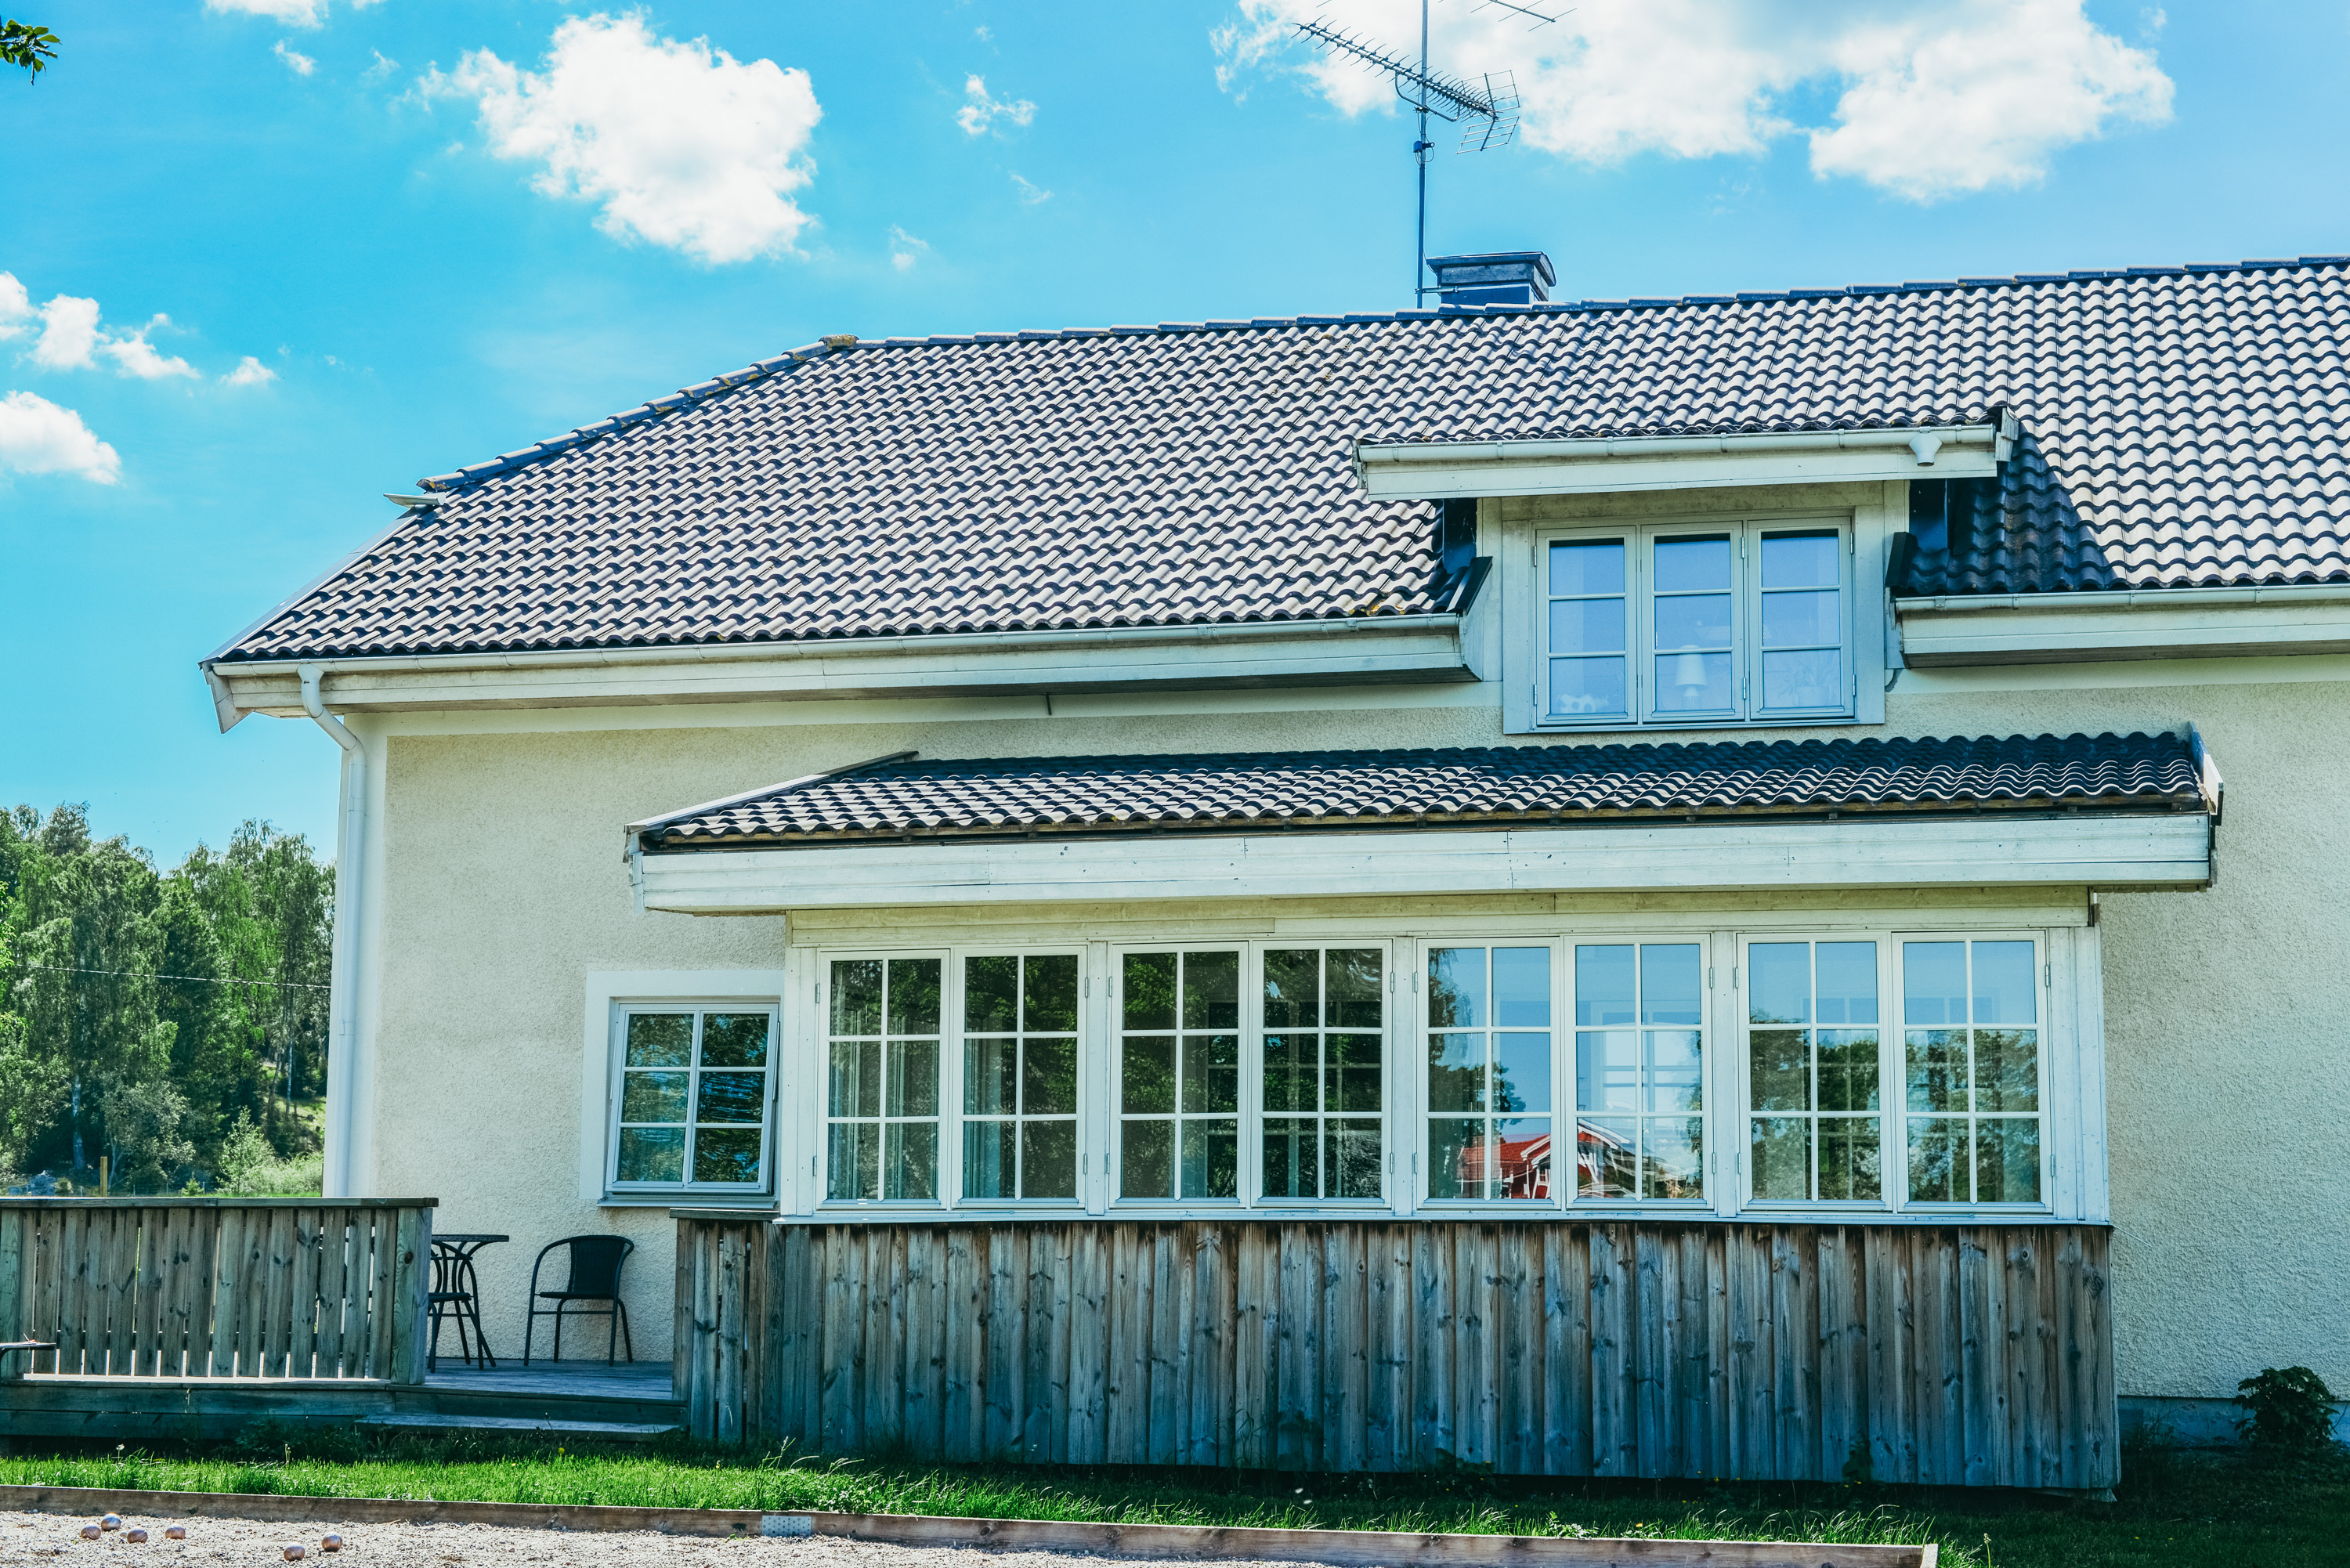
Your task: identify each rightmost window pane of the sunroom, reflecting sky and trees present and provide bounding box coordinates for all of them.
[1901,941,2040,1204]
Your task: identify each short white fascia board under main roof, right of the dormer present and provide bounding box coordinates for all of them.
[1894,583,2350,670]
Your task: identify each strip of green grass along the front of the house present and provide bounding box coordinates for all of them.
[0,1429,2350,1568]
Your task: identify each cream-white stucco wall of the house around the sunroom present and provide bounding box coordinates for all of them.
[360,658,2350,1396]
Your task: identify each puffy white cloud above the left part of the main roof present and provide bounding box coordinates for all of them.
[418,12,822,261]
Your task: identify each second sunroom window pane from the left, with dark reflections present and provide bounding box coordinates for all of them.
[964,955,1076,1199]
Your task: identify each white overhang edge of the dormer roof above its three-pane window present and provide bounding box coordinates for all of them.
[1354,416,2016,500]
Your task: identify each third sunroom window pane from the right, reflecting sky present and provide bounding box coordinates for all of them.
[1574,943,1706,1199]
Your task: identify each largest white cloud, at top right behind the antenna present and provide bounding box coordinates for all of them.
[1213,0,2171,202]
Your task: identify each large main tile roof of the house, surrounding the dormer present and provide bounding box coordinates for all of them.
[223,256,2350,658]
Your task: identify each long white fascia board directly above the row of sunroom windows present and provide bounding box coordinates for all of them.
[630,814,2211,915]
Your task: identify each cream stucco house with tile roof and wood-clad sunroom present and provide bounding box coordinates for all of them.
[204,256,2350,1490]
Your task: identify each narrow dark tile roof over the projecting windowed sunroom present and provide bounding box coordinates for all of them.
[639,733,2204,851]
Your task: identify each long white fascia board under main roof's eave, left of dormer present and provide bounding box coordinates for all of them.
[207,613,1476,714]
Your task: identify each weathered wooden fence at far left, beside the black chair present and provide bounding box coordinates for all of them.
[0,1199,432,1382]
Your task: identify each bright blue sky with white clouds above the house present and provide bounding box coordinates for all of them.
[0,0,2350,861]
